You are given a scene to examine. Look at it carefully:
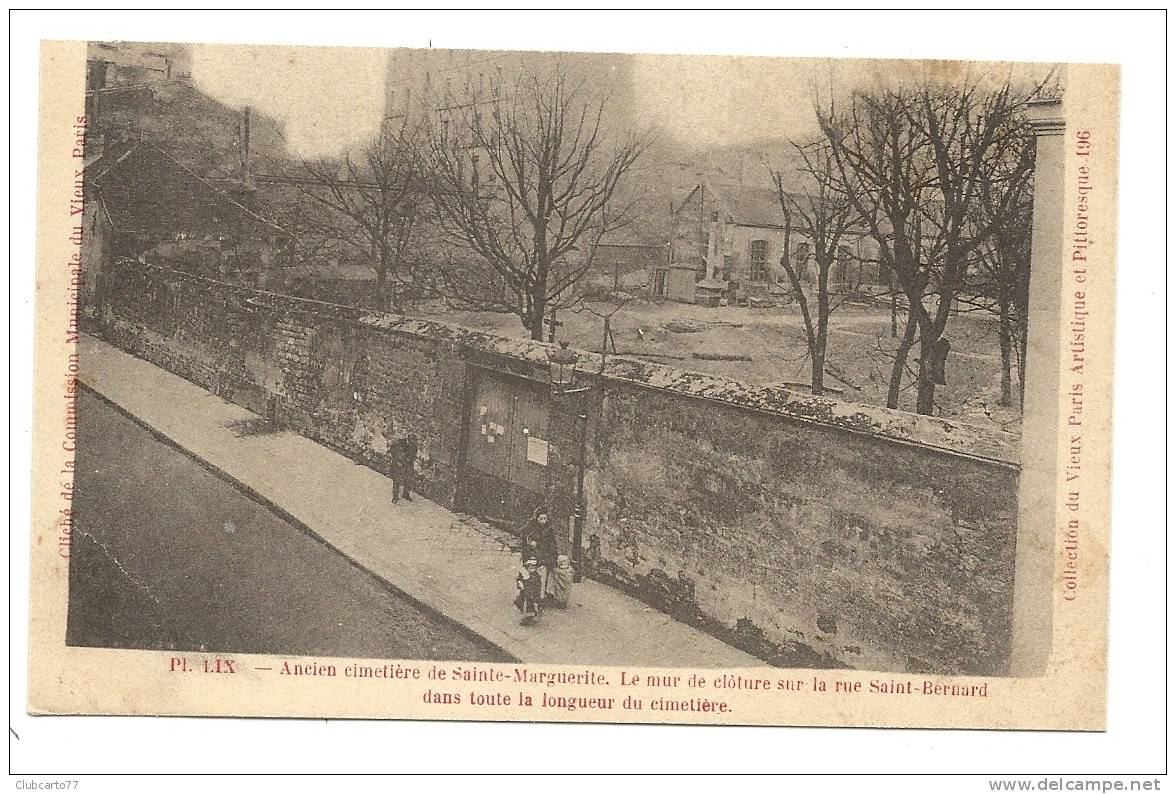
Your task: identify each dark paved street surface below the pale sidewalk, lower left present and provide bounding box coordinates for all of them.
[68,392,509,661]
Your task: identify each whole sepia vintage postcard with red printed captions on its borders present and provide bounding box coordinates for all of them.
[28,41,1118,730]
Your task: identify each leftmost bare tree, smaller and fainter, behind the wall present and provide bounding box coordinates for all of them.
[290,126,429,311]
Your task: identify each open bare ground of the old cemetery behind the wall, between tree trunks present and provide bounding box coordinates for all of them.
[421,301,1021,433]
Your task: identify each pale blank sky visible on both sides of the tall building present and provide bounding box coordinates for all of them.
[192,45,1048,158]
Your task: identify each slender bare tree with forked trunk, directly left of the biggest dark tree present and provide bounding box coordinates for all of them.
[769,141,855,394]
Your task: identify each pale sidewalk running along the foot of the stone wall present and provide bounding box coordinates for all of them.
[79,334,764,667]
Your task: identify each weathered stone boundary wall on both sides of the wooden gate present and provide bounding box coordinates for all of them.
[93,260,1020,674]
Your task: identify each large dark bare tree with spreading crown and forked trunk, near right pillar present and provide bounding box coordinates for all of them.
[817,84,1018,414]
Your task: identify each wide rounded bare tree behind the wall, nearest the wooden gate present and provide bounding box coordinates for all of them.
[429,66,646,340]
